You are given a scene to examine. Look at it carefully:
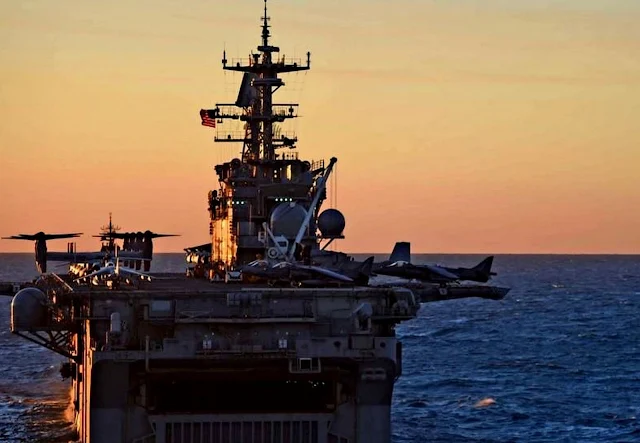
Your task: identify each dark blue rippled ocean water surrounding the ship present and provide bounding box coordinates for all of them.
[0,254,640,443]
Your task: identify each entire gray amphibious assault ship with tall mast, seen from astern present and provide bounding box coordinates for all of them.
[3,2,504,443]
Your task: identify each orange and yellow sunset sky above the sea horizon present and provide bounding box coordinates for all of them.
[0,0,640,253]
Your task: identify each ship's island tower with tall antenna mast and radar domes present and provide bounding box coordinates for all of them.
[193,3,344,278]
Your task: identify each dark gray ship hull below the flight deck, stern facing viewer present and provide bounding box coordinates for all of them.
[12,276,419,443]
